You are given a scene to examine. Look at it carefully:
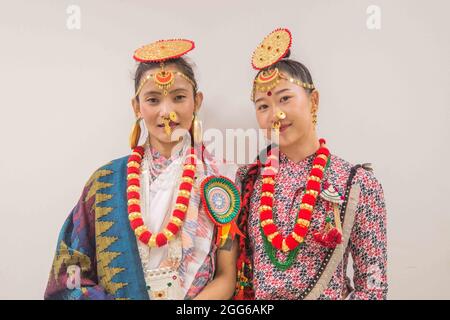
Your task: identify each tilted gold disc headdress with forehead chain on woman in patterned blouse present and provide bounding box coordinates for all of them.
[251,28,314,101]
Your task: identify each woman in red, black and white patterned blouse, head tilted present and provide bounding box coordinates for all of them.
[235,29,387,299]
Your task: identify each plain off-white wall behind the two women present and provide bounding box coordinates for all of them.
[0,0,450,299]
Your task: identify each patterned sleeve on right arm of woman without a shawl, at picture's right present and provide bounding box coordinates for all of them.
[349,169,388,300]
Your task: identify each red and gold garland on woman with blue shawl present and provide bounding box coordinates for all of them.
[127,146,197,247]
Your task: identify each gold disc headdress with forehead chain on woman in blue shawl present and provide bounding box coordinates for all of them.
[133,39,197,97]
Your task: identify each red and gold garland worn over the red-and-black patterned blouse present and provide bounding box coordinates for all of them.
[259,139,330,252]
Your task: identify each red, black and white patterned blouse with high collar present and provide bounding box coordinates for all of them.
[237,153,387,299]
